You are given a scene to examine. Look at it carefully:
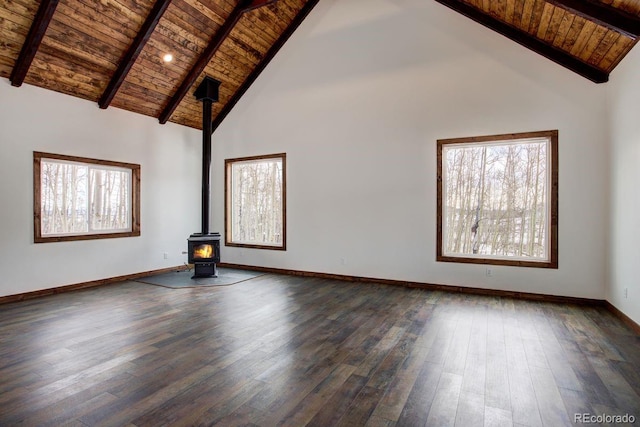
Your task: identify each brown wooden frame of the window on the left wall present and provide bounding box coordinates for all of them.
[33,151,140,243]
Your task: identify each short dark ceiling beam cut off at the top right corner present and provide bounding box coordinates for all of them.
[546,0,640,39]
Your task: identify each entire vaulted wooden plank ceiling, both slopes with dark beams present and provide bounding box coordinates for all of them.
[0,0,640,130]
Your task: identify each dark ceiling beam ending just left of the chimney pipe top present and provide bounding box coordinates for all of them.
[158,0,275,124]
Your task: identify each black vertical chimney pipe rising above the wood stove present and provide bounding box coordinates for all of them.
[194,76,220,236]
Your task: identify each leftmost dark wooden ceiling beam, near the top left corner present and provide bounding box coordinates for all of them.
[9,0,58,87]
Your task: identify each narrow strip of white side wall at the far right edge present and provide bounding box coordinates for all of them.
[607,47,640,324]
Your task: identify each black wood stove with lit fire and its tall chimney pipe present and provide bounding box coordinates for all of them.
[187,76,220,279]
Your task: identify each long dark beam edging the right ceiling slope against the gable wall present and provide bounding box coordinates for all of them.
[436,0,609,83]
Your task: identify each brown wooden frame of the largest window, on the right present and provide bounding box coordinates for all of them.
[436,130,558,269]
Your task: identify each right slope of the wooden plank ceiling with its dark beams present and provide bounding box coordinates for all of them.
[436,0,640,83]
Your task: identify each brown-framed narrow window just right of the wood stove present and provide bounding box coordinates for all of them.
[225,154,287,250]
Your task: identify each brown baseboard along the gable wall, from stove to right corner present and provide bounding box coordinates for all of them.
[218,263,606,306]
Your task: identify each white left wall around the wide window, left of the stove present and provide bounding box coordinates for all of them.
[0,79,202,296]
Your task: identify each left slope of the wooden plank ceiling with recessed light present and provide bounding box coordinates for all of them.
[0,0,318,129]
